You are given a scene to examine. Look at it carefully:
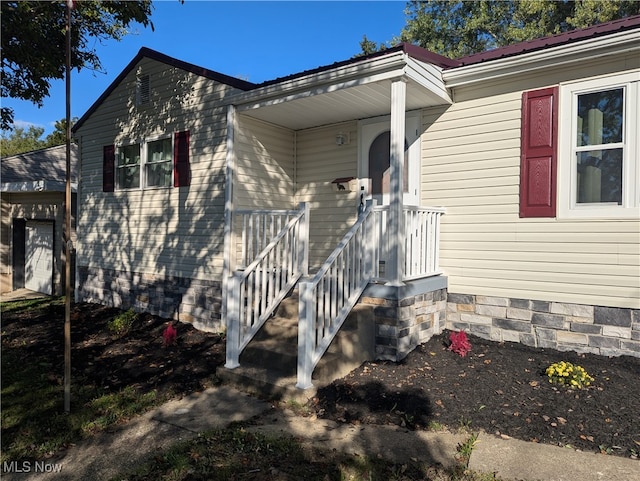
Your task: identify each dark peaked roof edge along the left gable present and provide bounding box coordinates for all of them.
[71,47,256,132]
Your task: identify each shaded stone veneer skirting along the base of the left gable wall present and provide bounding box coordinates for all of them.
[77,266,225,332]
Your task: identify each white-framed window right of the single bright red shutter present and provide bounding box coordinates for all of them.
[558,72,640,217]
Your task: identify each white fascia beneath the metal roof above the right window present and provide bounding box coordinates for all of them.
[442,30,640,88]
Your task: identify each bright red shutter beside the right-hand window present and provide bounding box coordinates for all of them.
[520,87,558,217]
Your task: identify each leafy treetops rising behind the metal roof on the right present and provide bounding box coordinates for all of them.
[360,0,640,58]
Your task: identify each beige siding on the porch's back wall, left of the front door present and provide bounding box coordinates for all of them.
[296,122,358,271]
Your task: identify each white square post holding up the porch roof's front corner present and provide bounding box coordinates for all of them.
[387,78,407,286]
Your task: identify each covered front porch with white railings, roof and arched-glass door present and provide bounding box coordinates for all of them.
[223,45,451,388]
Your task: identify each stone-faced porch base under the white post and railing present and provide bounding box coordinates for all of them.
[359,276,447,361]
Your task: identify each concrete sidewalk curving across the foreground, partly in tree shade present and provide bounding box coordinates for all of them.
[0,386,640,481]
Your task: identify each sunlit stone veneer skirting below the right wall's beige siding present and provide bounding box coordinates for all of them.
[446,293,640,357]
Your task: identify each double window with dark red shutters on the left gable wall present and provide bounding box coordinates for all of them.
[102,130,191,192]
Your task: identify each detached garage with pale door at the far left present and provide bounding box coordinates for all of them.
[0,144,78,295]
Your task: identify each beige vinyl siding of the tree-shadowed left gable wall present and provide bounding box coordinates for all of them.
[78,59,241,279]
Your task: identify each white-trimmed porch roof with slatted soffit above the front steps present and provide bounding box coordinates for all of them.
[228,44,457,130]
